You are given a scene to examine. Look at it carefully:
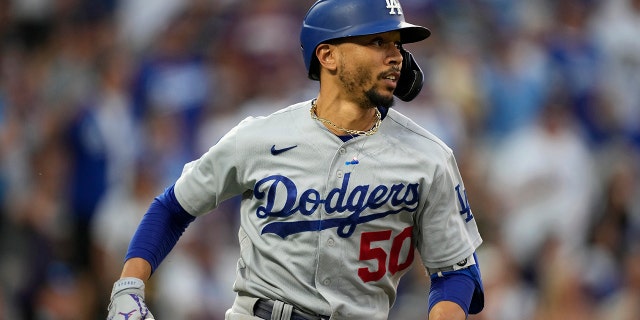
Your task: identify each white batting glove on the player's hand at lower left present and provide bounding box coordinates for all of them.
[107,278,155,320]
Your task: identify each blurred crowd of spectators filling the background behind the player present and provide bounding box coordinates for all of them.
[0,0,640,320]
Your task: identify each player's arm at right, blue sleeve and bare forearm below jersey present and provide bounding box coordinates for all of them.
[429,253,484,320]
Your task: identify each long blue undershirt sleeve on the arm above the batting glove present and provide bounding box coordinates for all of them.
[125,185,195,272]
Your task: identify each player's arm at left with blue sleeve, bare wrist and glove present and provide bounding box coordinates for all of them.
[108,186,195,319]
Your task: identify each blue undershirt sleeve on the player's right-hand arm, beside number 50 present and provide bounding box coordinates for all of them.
[429,253,484,315]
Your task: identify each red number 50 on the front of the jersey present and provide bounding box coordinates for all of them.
[358,227,414,282]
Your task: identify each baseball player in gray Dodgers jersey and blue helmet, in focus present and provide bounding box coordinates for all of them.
[109,0,484,320]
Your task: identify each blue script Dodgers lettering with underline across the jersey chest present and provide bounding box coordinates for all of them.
[253,173,420,239]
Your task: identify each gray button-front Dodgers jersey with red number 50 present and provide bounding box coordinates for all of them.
[175,101,482,319]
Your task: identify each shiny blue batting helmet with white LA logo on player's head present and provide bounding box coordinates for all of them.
[300,0,431,80]
